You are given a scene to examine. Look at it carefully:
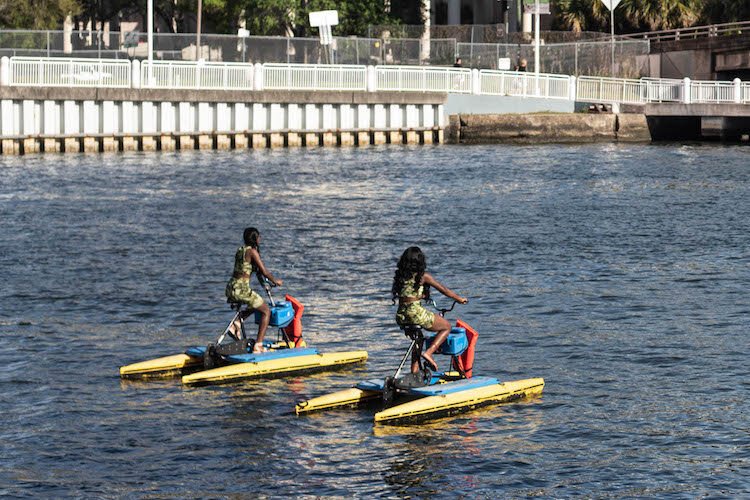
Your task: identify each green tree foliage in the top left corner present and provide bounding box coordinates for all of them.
[0,0,81,30]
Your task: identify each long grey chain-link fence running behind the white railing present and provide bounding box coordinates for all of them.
[0,25,649,78]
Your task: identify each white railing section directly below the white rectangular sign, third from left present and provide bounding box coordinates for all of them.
[263,64,367,91]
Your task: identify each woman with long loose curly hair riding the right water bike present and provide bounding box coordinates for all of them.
[391,247,468,373]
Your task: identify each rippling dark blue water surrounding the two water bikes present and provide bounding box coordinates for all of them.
[0,144,750,497]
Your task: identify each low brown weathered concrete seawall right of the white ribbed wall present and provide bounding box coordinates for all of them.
[447,113,651,144]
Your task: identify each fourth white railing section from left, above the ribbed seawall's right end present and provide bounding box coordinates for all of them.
[375,66,472,94]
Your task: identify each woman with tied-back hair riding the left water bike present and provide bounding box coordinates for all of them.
[225,227,283,354]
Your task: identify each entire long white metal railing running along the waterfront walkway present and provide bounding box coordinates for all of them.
[0,57,750,104]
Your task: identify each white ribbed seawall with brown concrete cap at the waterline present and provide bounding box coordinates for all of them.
[0,87,445,154]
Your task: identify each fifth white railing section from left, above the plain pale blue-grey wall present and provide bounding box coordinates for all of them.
[479,69,571,99]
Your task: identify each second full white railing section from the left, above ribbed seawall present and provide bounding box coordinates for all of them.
[140,61,254,90]
